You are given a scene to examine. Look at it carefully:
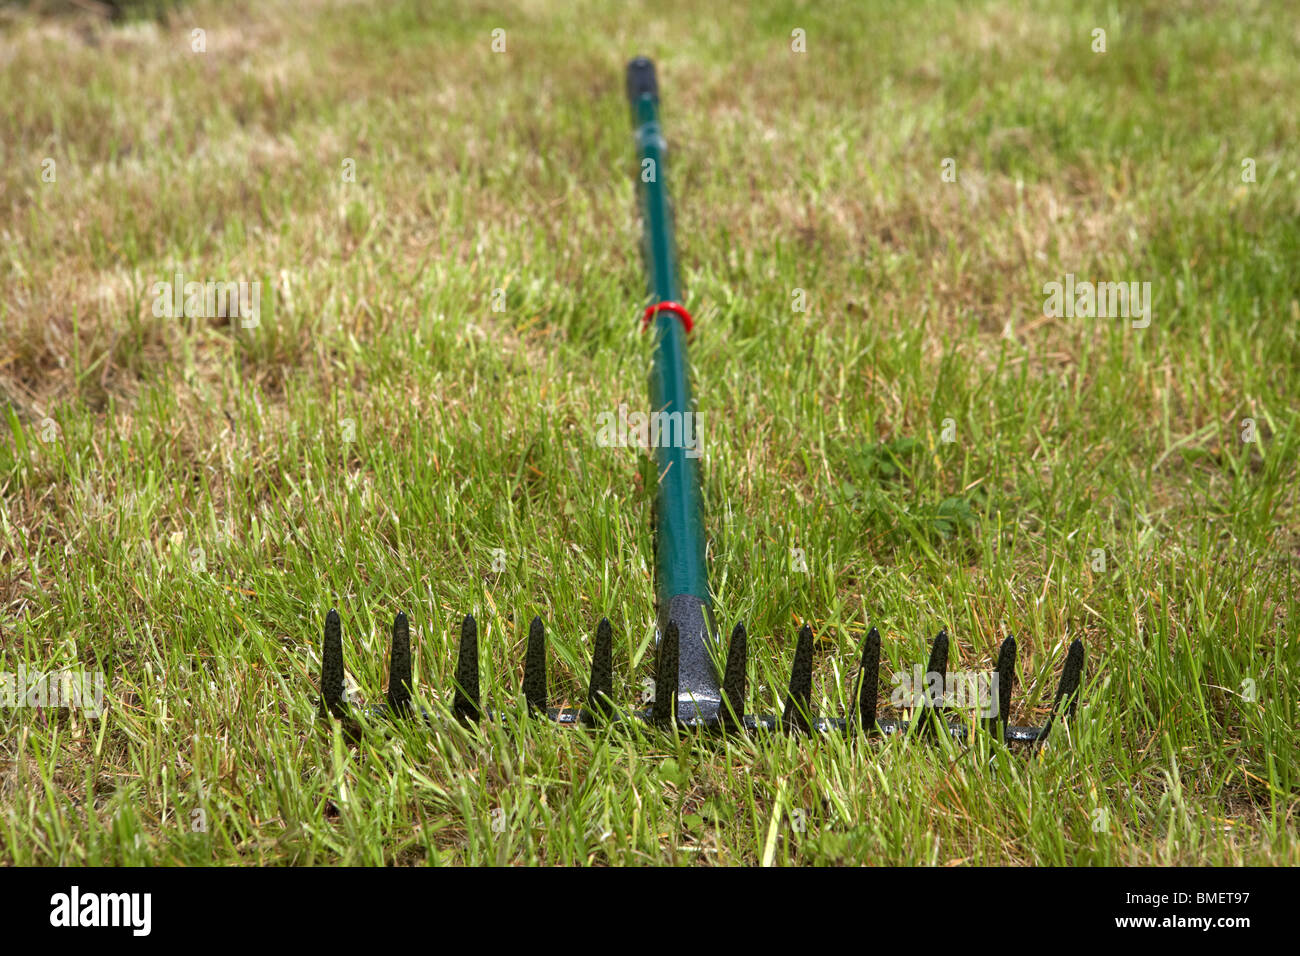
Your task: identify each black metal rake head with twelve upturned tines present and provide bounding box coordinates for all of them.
[320,609,1083,743]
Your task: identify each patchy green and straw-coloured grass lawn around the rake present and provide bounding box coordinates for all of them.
[0,0,1300,865]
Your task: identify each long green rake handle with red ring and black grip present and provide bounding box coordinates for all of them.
[628,57,722,723]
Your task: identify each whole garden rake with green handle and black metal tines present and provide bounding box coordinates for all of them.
[320,57,1084,743]
